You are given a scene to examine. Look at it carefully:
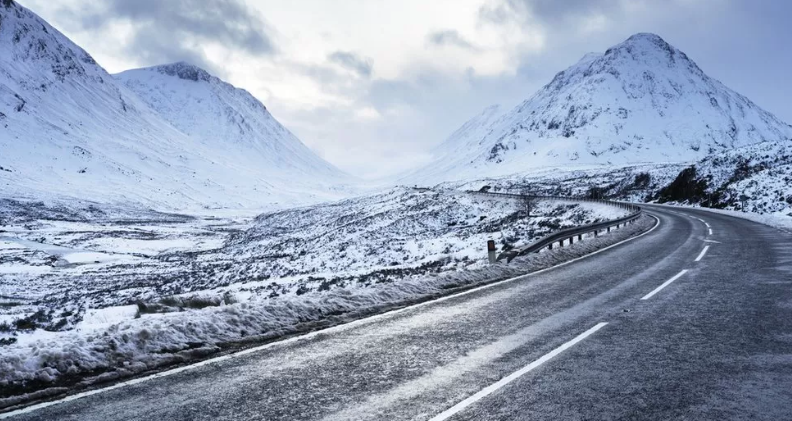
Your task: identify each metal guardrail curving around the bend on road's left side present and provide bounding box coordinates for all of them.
[467,191,643,263]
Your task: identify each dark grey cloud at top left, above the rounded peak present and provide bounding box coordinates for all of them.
[55,0,275,68]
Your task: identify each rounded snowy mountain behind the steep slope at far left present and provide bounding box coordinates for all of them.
[114,63,345,182]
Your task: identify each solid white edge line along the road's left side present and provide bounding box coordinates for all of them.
[0,215,660,420]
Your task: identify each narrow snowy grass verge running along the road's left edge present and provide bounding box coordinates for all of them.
[0,213,654,407]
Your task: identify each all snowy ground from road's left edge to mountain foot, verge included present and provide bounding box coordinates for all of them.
[0,188,627,397]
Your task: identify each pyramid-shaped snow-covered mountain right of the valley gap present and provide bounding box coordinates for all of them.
[402,34,792,183]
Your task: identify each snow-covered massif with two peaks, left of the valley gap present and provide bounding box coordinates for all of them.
[0,1,349,209]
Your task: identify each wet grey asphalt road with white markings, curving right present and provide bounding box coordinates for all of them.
[6,207,792,421]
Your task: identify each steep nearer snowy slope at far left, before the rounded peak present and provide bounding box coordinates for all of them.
[0,1,352,209]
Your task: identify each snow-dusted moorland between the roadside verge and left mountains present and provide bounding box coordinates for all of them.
[0,188,624,331]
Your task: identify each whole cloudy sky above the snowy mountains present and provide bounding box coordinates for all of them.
[20,0,792,178]
